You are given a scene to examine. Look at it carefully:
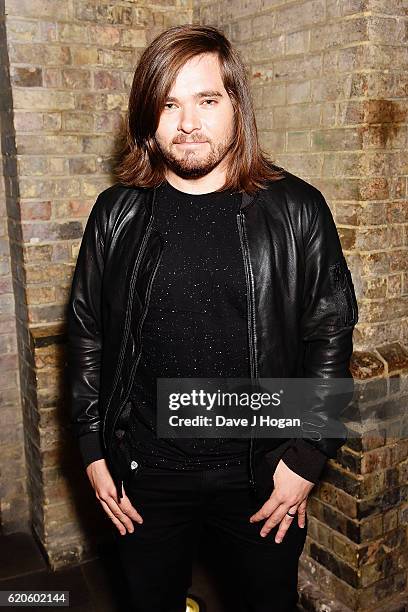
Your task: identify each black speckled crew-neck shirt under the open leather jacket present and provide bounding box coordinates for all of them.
[121,181,250,469]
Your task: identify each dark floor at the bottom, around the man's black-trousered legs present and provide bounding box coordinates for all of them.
[0,533,302,612]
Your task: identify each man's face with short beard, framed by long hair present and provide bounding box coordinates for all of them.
[155,53,234,179]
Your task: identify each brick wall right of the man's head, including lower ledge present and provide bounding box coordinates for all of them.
[193,0,408,611]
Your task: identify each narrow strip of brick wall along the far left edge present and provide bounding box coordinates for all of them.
[0,1,28,533]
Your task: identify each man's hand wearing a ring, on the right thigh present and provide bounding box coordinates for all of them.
[249,459,314,543]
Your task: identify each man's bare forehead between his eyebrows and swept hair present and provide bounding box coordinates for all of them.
[169,53,225,95]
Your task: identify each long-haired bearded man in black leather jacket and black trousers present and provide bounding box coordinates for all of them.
[68,25,357,612]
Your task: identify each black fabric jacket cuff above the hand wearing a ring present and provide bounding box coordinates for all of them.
[281,438,328,484]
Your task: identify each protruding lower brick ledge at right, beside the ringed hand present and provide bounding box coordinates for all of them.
[302,350,408,610]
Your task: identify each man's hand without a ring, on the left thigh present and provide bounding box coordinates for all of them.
[86,459,143,535]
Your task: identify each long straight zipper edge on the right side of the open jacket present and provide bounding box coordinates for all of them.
[237,211,257,488]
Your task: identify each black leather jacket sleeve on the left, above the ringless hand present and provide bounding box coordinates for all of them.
[67,197,104,467]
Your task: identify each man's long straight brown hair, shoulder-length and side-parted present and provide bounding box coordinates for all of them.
[115,24,284,193]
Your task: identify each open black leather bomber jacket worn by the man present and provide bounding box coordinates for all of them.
[68,171,357,496]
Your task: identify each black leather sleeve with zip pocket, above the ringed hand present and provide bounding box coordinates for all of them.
[282,191,358,483]
